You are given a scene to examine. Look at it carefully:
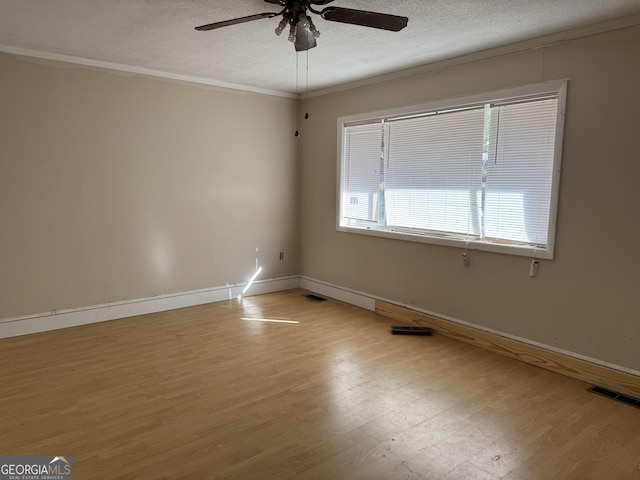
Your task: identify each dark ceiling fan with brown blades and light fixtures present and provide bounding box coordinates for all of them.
[196,0,409,52]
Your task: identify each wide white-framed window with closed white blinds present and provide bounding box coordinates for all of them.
[338,81,566,258]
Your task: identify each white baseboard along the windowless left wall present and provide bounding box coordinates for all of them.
[0,275,300,338]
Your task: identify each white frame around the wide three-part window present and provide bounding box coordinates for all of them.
[336,80,568,259]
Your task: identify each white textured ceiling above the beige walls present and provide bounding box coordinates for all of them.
[0,0,640,94]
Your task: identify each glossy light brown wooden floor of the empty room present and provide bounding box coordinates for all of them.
[0,290,640,480]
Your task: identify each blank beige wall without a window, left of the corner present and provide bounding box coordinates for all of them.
[0,54,298,319]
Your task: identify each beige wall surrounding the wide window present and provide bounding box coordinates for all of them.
[300,26,640,371]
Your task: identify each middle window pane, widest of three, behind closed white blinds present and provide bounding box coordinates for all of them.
[385,108,484,235]
